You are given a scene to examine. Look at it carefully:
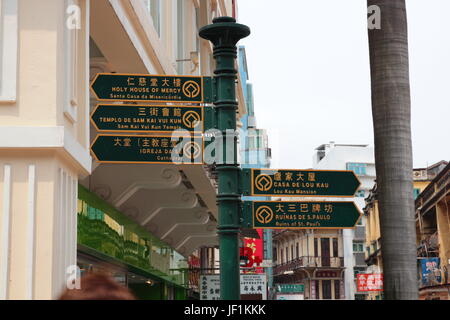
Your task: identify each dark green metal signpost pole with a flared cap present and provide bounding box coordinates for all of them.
[199,17,250,300]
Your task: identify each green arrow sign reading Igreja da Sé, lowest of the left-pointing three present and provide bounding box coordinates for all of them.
[91,134,203,164]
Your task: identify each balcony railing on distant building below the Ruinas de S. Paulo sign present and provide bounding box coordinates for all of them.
[274,257,344,274]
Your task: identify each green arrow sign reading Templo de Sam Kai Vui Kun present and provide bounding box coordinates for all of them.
[91,104,203,132]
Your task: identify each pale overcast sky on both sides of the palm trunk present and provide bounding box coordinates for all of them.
[238,0,450,168]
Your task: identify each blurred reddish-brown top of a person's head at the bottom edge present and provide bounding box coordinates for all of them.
[59,273,135,300]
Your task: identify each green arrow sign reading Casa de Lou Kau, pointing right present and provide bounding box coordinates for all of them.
[242,169,360,197]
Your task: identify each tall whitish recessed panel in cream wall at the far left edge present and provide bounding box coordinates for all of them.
[0,0,18,102]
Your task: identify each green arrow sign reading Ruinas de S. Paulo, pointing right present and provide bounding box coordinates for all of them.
[243,201,362,229]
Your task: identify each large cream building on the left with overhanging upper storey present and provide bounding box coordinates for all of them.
[0,0,246,299]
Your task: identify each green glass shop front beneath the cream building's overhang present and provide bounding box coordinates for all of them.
[77,186,187,300]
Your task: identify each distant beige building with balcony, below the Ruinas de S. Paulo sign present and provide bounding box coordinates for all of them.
[273,226,345,300]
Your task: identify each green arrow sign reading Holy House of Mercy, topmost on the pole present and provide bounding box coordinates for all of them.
[91,73,213,103]
